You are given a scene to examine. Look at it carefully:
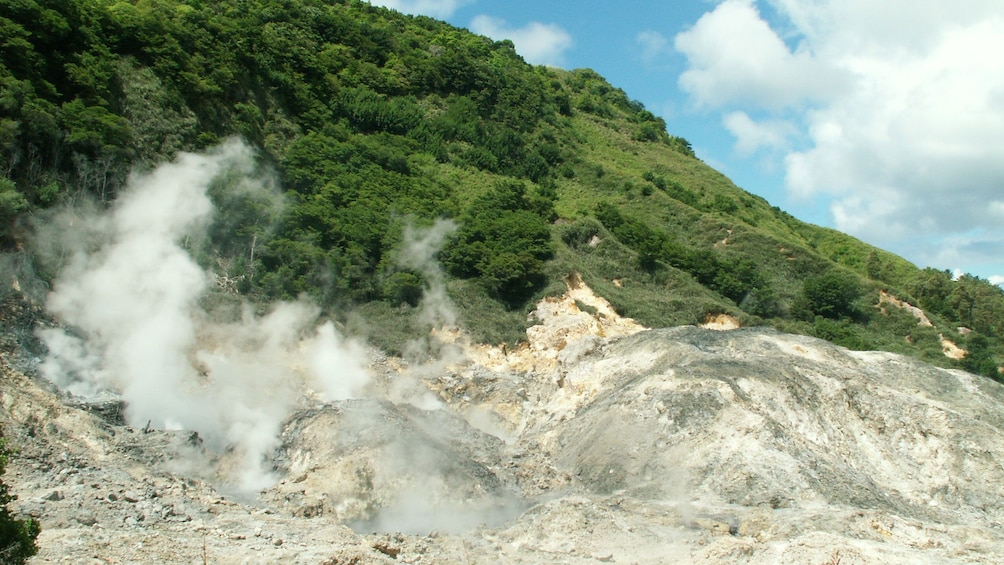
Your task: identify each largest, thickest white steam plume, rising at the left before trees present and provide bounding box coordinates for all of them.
[40,140,368,491]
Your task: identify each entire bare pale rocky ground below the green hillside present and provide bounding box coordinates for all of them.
[0,280,1004,565]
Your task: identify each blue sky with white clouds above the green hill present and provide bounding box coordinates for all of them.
[370,0,1004,284]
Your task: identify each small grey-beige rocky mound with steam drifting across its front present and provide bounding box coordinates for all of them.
[268,400,521,534]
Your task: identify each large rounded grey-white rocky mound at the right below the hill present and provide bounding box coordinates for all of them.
[553,327,1004,521]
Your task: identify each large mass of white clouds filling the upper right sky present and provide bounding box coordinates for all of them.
[675,0,1004,274]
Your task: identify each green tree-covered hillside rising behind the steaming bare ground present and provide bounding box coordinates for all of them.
[0,0,1004,378]
